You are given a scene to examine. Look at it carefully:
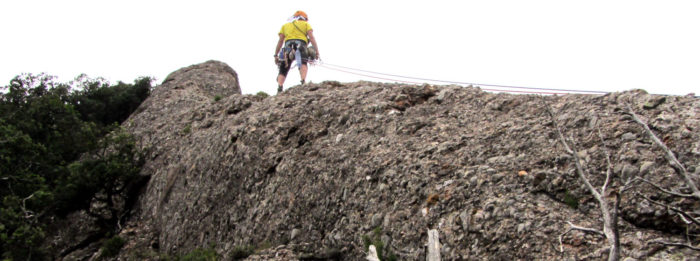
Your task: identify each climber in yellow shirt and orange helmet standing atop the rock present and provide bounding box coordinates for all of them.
[275,11,321,93]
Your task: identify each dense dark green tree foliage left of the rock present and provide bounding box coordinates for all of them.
[0,74,152,260]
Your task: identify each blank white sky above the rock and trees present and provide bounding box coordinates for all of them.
[0,0,700,95]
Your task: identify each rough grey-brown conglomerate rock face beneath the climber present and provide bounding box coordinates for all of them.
[106,61,700,260]
